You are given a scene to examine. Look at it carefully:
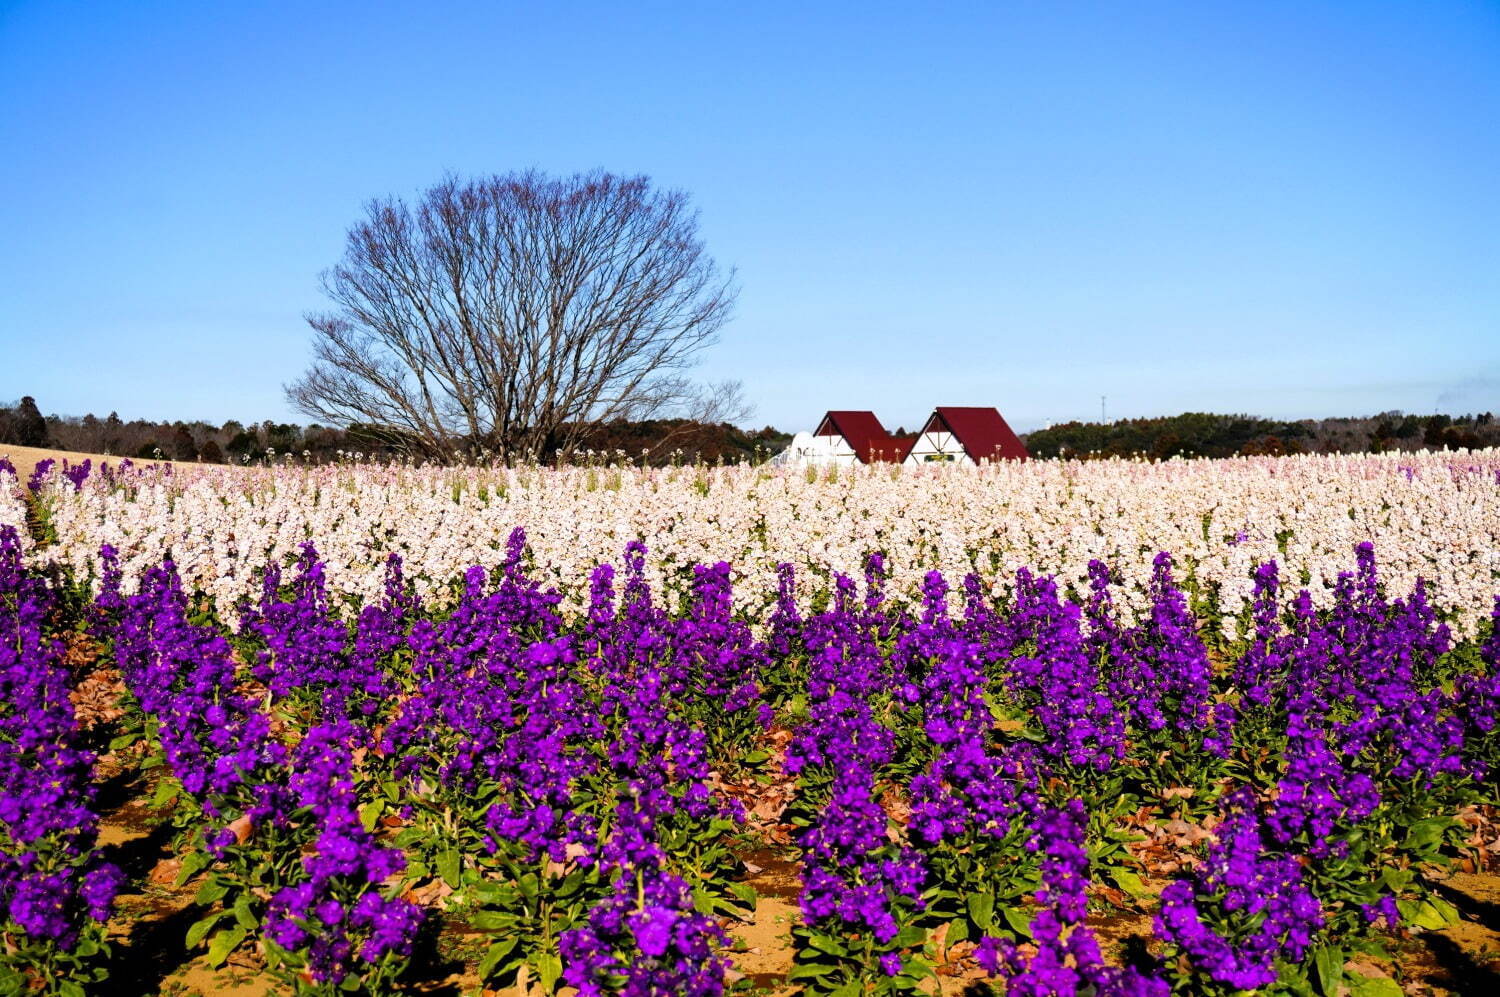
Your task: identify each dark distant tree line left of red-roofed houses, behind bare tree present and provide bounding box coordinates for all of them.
[0,396,792,463]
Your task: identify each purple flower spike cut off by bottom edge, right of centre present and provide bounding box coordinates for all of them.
[974,799,1170,997]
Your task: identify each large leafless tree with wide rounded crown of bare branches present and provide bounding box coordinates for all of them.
[287,172,735,457]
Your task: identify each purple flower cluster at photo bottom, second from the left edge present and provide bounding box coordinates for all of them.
[264,721,423,985]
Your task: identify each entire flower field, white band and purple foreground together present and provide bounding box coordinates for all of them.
[0,451,1500,997]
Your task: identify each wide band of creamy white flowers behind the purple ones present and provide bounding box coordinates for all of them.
[0,450,1500,633]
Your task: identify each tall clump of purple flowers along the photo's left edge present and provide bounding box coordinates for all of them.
[0,526,125,947]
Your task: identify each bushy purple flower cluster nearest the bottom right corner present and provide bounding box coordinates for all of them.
[1157,790,1323,990]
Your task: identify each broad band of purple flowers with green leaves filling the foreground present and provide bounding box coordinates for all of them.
[0,521,1500,996]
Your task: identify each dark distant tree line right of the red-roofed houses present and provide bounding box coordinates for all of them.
[1023,412,1500,460]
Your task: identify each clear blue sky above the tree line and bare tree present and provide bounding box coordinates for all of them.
[0,0,1500,430]
